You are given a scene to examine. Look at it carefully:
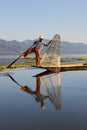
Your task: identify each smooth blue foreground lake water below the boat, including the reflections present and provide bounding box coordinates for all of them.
[0,68,87,130]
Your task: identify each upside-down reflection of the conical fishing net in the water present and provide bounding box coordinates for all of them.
[41,73,62,109]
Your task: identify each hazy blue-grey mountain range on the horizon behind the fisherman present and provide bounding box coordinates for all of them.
[0,39,87,55]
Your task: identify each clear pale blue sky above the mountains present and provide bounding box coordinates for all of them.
[0,0,87,43]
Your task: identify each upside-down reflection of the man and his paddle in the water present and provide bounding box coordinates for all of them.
[8,74,50,109]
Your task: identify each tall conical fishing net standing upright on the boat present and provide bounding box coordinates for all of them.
[40,34,61,67]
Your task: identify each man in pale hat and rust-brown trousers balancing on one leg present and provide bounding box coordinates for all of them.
[20,36,51,66]
